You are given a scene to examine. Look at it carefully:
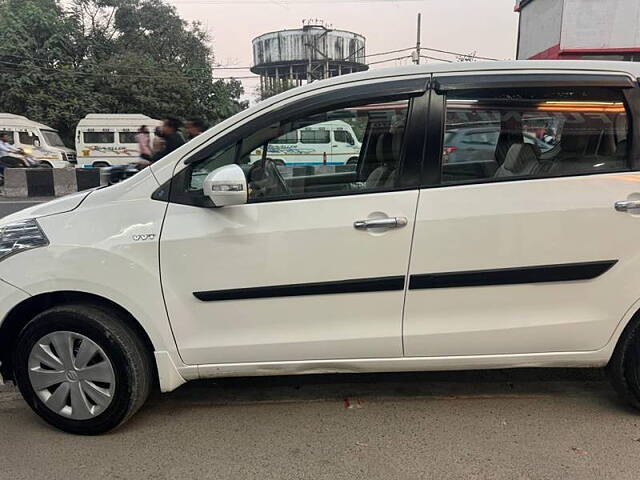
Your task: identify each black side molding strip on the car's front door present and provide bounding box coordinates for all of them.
[193,276,404,302]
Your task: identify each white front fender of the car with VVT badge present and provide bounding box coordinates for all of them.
[0,172,181,365]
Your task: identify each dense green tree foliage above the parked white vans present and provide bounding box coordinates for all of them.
[0,0,246,144]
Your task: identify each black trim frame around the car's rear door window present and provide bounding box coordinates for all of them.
[420,72,640,189]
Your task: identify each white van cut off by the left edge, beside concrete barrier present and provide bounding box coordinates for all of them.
[0,113,76,168]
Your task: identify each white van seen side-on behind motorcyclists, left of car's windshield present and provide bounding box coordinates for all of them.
[76,113,162,167]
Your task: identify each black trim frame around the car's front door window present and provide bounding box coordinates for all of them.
[160,74,431,208]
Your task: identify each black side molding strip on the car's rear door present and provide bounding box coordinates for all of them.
[409,260,618,290]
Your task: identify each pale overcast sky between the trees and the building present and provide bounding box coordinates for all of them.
[168,0,518,99]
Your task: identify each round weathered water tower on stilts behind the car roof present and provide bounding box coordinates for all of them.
[251,21,369,91]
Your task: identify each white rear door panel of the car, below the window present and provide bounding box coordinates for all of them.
[404,173,640,357]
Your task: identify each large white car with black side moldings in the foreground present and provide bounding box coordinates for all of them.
[0,61,640,434]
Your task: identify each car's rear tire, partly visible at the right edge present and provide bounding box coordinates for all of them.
[607,315,640,410]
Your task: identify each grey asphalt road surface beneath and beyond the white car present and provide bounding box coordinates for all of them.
[0,200,640,480]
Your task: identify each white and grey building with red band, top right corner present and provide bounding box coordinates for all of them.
[515,0,640,61]
